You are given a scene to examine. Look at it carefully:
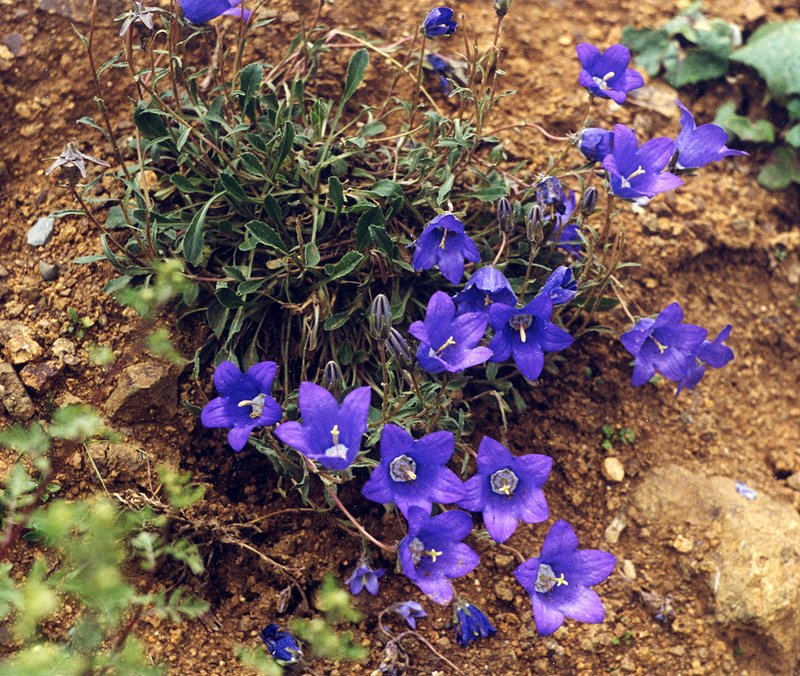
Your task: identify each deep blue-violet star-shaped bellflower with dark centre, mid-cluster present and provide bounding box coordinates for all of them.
[489,293,572,380]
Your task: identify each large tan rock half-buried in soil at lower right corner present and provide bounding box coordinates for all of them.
[632,465,800,674]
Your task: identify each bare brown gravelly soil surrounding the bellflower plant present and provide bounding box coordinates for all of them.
[0,0,800,674]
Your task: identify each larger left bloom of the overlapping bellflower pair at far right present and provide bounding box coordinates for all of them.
[619,303,706,387]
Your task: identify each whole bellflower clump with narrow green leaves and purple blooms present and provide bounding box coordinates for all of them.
[37,0,743,669]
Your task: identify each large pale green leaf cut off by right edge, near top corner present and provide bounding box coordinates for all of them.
[731,20,800,99]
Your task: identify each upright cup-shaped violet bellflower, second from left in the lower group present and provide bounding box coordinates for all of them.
[275,382,370,470]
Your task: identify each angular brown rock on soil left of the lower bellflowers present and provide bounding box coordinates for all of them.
[106,361,178,422]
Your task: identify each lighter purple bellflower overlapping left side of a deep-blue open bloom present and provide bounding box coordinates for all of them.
[408,291,492,373]
